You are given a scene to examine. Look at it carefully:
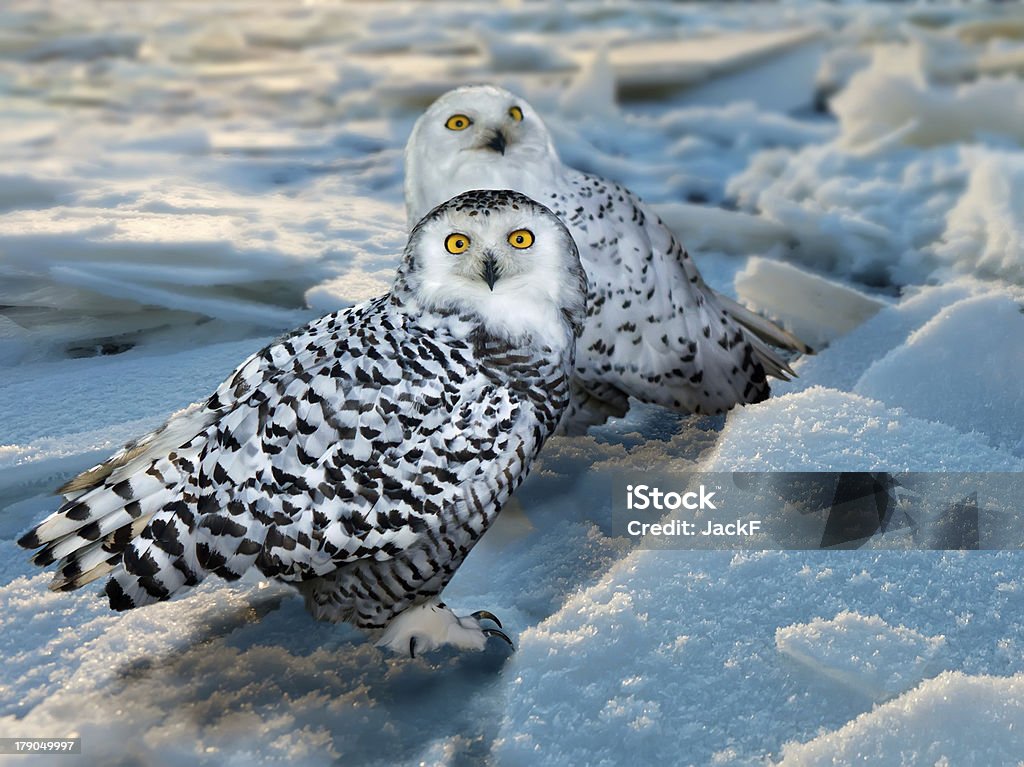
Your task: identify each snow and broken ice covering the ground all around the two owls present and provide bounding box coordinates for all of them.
[0,0,1024,765]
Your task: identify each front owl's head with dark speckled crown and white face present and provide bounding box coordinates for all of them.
[394,189,587,346]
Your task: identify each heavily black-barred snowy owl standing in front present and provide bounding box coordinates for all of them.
[19,190,587,654]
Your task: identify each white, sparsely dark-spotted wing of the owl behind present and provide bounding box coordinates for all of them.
[564,172,795,413]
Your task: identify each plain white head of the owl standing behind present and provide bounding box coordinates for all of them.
[406,85,561,225]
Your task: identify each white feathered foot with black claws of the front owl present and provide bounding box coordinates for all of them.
[377,601,515,657]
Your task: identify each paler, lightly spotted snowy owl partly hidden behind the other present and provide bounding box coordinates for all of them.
[406,86,809,432]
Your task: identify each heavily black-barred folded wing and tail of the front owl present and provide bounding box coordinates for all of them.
[20,300,536,609]
